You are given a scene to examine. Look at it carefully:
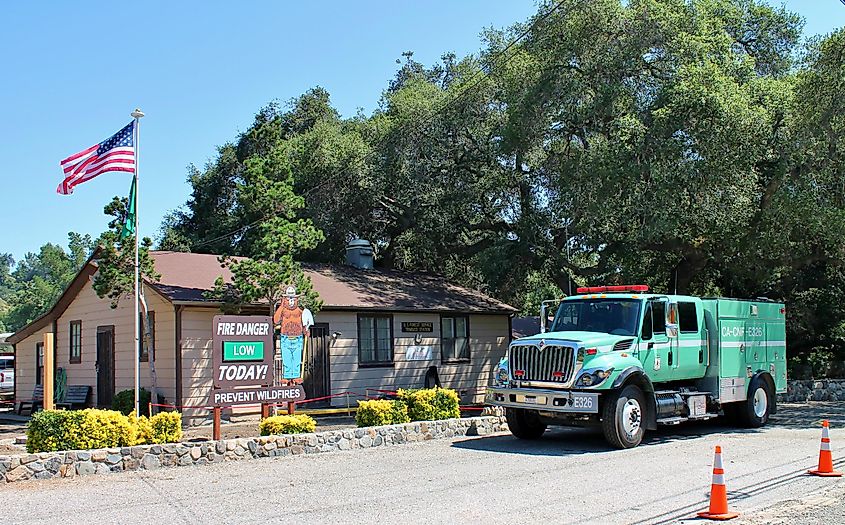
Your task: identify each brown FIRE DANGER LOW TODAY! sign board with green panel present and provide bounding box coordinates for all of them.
[212,315,273,388]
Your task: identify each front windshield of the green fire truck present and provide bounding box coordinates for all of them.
[551,299,642,335]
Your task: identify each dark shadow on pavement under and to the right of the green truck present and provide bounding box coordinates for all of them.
[452,402,845,456]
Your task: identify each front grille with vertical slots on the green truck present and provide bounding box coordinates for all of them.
[508,345,575,383]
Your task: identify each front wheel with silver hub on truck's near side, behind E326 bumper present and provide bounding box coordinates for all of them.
[601,385,646,448]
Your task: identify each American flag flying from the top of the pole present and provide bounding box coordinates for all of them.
[56,120,135,195]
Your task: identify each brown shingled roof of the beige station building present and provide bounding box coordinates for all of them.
[151,252,516,313]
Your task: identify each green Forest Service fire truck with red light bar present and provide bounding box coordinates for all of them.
[486,285,786,448]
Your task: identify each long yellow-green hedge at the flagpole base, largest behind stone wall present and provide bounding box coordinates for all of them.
[26,408,182,453]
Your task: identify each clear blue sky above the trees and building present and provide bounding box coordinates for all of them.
[0,0,845,259]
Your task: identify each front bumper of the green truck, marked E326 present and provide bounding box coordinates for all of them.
[484,387,599,414]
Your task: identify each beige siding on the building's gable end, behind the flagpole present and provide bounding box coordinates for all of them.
[15,281,176,406]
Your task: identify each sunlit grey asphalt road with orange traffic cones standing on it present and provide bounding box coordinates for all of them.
[0,403,845,525]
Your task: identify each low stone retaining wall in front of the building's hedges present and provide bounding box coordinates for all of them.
[0,416,508,484]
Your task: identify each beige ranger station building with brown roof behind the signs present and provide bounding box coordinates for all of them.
[9,241,515,423]
